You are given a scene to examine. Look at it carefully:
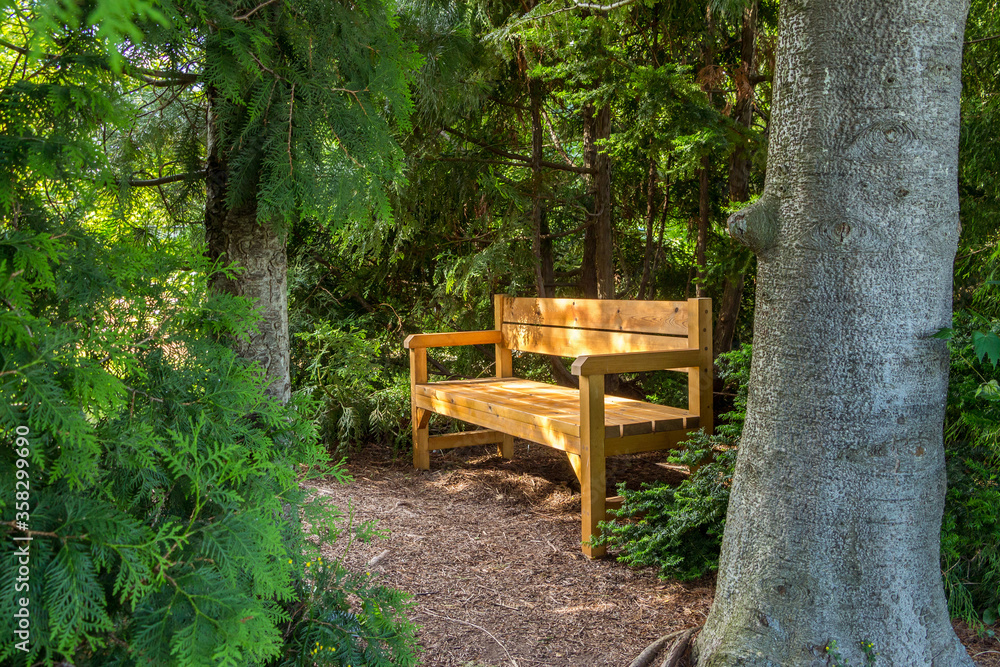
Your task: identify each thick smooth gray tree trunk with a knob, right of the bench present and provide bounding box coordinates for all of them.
[697,0,972,667]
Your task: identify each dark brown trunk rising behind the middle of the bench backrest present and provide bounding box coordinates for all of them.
[580,104,615,299]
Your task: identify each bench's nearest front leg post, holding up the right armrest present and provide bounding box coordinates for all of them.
[580,375,606,558]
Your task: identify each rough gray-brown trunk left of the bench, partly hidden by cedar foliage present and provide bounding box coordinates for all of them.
[205,91,291,403]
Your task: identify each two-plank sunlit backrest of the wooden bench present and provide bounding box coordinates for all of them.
[494,294,711,357]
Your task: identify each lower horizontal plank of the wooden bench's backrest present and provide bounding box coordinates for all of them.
[502,322,688,357]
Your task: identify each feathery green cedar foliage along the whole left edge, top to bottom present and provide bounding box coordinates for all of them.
[0,1,416,666]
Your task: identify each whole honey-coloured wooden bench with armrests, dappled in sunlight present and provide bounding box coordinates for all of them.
[403,295,712,558]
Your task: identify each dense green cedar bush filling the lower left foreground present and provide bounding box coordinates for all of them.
[0,223,416,667]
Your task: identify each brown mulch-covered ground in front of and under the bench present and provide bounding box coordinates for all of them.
[311,441,1000,667]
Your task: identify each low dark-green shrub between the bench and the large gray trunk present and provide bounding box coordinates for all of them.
[596,345,751,579]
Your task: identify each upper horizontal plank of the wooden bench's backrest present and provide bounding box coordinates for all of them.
[503,298,689,336]
